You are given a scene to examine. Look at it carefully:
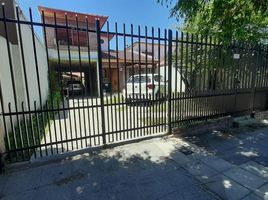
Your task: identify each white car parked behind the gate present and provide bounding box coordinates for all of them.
[123,74,167,101]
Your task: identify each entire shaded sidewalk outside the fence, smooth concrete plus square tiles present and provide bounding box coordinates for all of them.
[0,119,268,200]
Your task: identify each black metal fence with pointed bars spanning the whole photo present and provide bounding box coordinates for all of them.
[0,5,268,162]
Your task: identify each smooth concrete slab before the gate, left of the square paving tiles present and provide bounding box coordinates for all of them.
[0,138,215,200]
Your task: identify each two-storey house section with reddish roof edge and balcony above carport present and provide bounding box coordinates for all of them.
[38,6,113,95]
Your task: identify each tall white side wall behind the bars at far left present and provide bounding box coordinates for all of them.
[0,7,49,152]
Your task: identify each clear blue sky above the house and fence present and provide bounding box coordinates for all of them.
[17,0,182,33]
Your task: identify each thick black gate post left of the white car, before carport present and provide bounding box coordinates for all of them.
[96,19,106,145]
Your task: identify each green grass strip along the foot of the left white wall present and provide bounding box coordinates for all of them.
[5,92,62,160]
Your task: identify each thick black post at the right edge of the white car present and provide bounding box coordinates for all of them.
[167,30,172,134]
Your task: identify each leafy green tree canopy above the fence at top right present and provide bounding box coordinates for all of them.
[158,0,268,44]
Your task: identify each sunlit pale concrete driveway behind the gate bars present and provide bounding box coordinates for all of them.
[36,97,166,159]
